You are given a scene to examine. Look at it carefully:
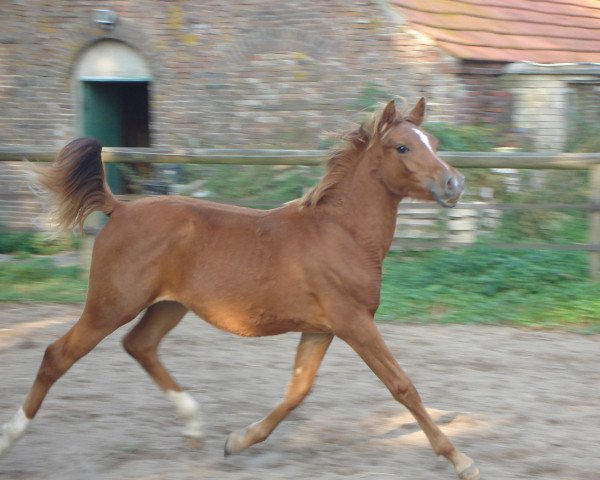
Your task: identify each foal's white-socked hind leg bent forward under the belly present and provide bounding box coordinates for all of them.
[123,301,203,441]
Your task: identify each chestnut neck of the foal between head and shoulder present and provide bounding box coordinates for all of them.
[329,152,400,261]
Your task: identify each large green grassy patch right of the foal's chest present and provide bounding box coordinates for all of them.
[378,246,600,332]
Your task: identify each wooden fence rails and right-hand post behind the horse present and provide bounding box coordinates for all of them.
[0,147,600,279]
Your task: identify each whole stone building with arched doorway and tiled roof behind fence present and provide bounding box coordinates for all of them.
[0,0,600,229]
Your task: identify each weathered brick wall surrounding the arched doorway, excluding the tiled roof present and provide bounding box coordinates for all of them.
[0,0,478,149]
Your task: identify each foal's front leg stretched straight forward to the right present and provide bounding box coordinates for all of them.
[339,317,479,480]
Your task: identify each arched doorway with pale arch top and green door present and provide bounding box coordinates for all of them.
[74,40,152,192]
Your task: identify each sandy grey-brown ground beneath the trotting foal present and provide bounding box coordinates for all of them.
[0,304,600,480]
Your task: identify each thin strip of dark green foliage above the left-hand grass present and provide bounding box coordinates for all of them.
[0,232,80,255]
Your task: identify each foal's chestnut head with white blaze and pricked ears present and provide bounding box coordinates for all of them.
[372,98,464,207]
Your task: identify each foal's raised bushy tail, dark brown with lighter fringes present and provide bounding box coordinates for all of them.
[35,138,119,230]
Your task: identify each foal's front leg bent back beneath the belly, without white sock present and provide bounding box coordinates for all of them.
[225,333,333,455]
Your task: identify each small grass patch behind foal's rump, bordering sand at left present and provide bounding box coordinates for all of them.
[0,258,87,303]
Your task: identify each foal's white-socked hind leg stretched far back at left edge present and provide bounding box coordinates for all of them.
[0,306,137,454]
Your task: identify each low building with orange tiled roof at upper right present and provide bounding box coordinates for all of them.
[391,0,600,151]
